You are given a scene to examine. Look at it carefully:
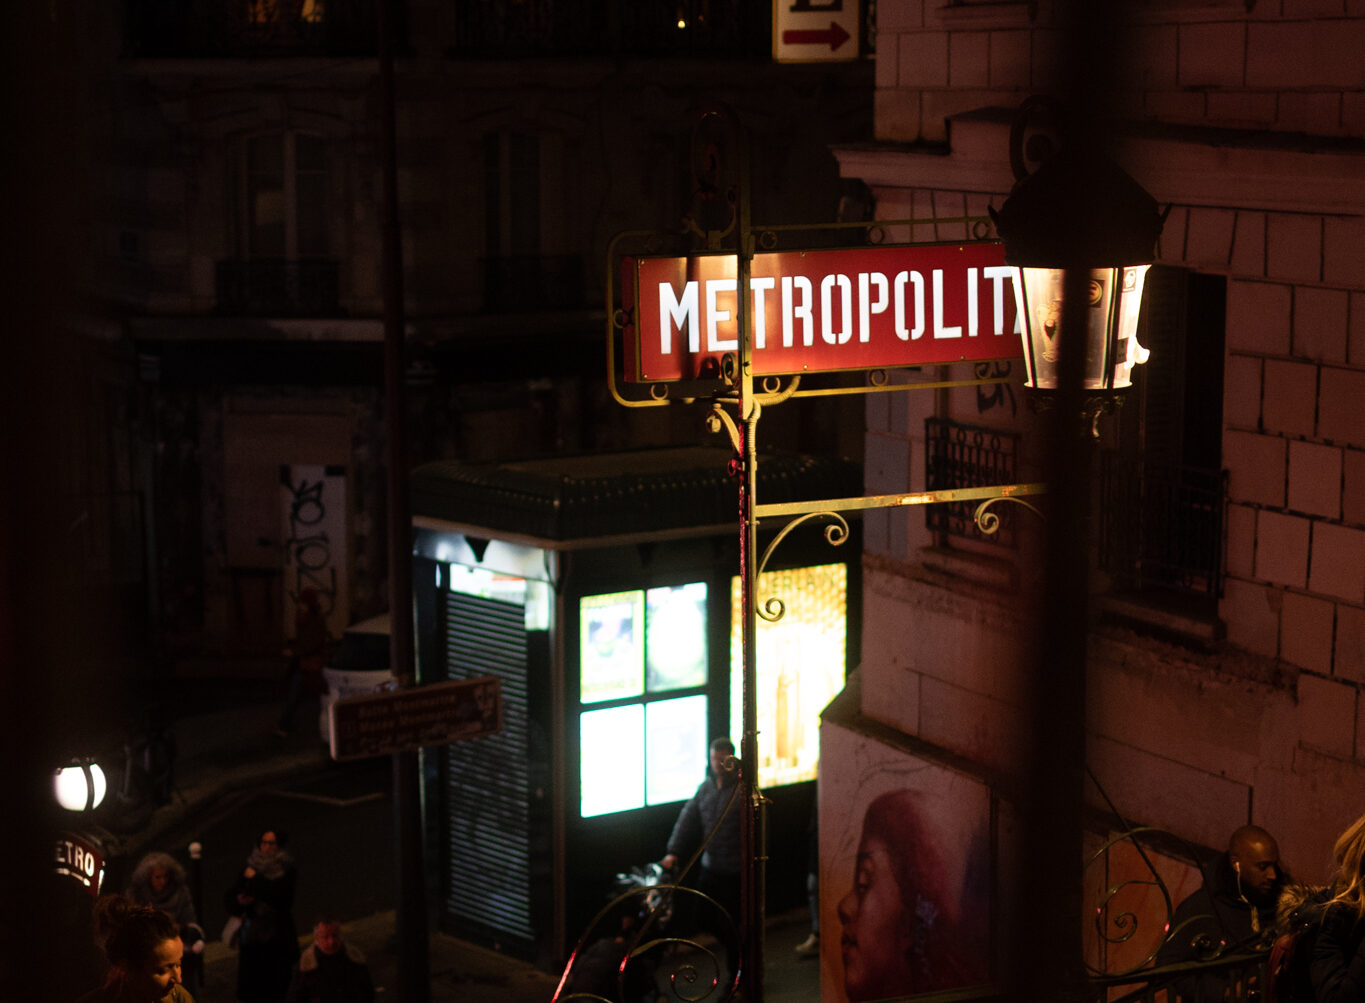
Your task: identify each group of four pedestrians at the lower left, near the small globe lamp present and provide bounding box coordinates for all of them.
[78,828,374,1003]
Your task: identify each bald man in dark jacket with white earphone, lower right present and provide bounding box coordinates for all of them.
[1156,826,1289,1000]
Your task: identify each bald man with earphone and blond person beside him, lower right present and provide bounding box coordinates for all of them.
[1156,815,1365,1003]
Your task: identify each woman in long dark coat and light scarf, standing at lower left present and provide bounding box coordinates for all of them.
[224,830,299,1003]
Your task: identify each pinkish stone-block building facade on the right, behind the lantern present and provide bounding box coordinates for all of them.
[819,0,1365,1000]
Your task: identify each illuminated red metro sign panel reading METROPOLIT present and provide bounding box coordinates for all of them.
[621,242,1022,383]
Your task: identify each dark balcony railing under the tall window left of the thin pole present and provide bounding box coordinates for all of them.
[216,258,341,317]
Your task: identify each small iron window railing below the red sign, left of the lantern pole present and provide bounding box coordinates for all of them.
[924,418,1020,547]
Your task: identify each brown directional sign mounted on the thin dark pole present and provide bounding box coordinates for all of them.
[332,675,502,760]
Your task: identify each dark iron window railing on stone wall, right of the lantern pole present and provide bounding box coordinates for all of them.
[1100,453,1227,598]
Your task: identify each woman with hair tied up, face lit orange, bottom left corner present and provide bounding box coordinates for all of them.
[76,895,194,1003]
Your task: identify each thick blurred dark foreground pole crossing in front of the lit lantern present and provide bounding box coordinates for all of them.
[1013,0,1121,1003]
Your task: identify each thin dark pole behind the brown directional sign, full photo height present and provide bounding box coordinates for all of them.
[375,0,430,1003]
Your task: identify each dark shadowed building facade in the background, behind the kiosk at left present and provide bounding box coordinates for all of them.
[102,7,871,665]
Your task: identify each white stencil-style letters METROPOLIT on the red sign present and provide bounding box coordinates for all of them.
[657,265,1021,355]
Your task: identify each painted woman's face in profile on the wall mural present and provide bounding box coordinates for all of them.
[838,835,915,1003]
